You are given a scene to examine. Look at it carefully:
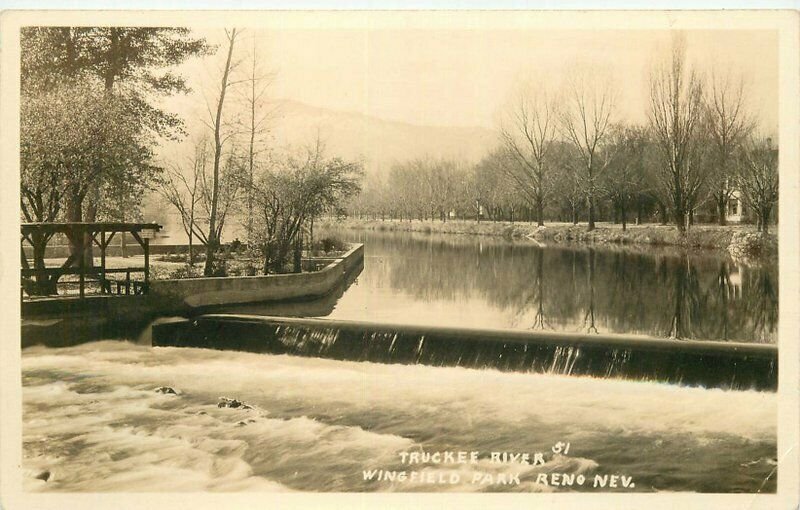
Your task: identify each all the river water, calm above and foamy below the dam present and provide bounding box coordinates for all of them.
[22,232,777,492]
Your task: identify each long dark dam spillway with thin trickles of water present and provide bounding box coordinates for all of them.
[152,314,778,391]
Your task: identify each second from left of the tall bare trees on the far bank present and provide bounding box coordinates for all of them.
[559,66,615,230]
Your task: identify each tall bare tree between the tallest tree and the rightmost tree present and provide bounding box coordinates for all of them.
[706,69,753,225]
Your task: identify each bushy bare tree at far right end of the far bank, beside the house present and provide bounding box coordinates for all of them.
[736,138,778,233]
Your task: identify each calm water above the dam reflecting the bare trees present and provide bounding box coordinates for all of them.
[316,230,778,342]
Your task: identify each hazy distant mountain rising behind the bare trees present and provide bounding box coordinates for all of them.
[271,100,498,174]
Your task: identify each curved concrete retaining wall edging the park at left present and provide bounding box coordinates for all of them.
[149,244,364,310]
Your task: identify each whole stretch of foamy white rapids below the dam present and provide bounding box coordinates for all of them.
[22,342,776,491]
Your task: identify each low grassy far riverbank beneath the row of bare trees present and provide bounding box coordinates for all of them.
[323,218,778,260]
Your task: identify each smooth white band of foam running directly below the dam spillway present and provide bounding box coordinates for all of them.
[23,342,777,439]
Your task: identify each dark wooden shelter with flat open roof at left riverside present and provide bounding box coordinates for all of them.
[21,222,161,299]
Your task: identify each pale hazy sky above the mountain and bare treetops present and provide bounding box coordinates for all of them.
[173,29,778,132]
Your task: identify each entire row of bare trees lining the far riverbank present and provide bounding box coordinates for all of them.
[348,36,778,232]
